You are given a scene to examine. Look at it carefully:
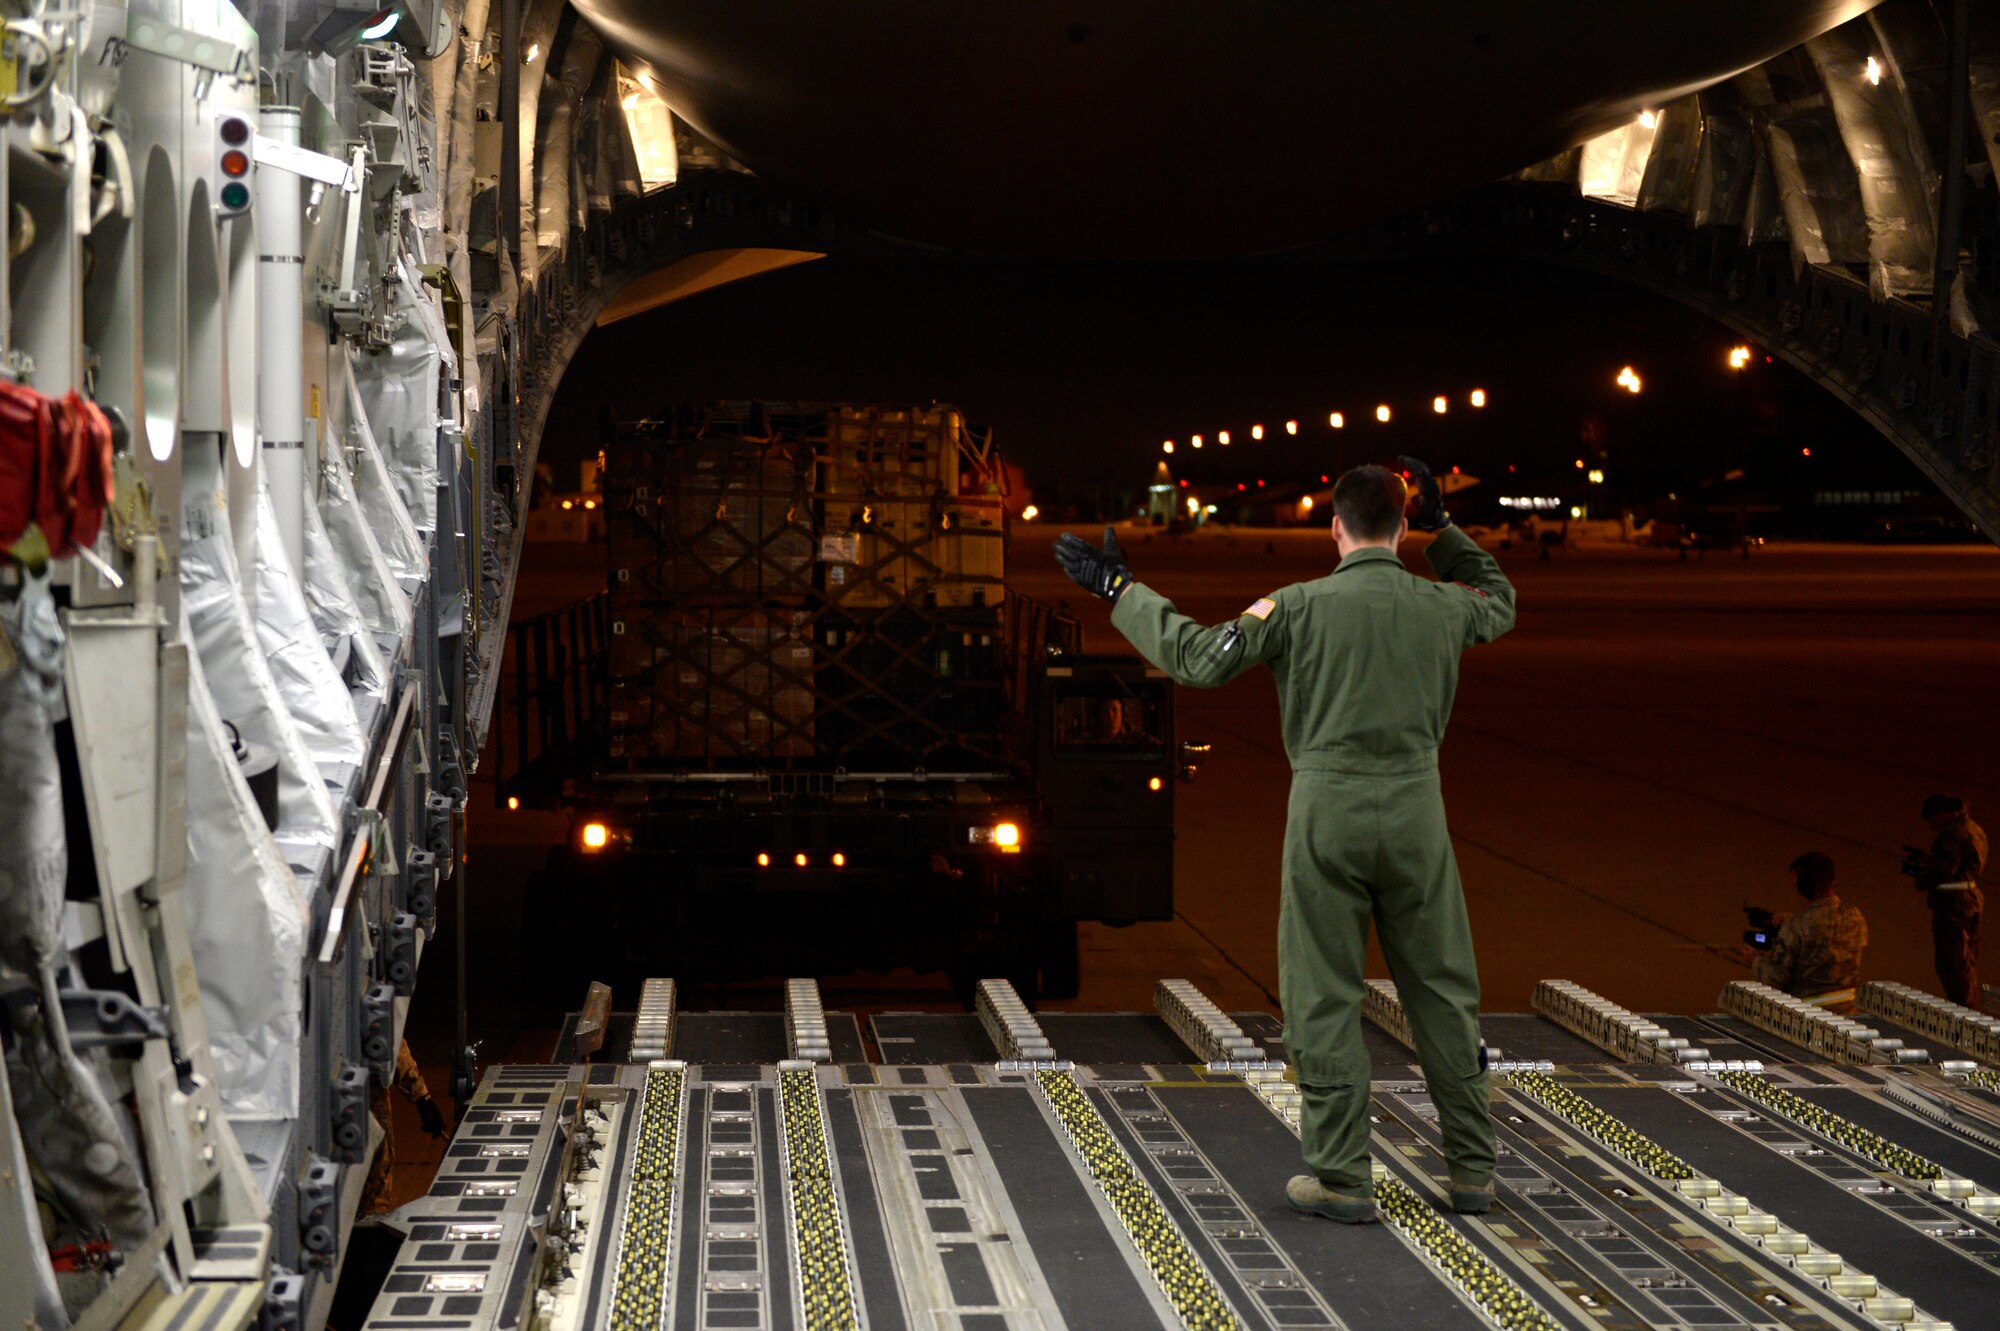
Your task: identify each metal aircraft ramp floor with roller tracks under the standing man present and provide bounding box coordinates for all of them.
[366,981,2000,1331]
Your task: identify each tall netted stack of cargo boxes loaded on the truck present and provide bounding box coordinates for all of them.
[604,402,1046,771]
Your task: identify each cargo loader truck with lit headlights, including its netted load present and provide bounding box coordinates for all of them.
[496,402,1204,997]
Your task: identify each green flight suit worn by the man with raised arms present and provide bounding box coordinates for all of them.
[1112,528,1514,1193]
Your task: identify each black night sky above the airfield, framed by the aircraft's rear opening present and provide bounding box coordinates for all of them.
[544,258,1932,519]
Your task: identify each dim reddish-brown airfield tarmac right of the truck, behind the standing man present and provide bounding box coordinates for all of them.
[1010,524,2000,1011]
